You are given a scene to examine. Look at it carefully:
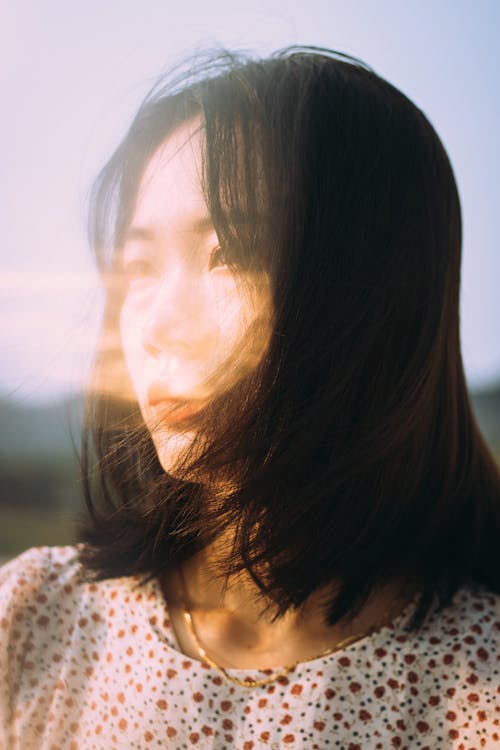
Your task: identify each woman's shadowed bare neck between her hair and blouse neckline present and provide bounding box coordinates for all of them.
[163,543,413,669]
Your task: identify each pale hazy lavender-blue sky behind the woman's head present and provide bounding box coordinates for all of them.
[0,0,500,403]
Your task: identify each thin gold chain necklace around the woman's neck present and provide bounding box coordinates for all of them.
[179,572,410,688]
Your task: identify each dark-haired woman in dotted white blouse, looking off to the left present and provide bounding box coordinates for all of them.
[2,48,500,750]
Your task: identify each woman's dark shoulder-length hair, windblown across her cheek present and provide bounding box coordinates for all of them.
[79,48,500,627]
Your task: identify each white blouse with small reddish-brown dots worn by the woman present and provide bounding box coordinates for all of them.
[0,547,500,750]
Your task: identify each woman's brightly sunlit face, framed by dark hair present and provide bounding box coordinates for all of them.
[120,121,272,473]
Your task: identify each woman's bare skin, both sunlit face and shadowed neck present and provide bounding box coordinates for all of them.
[120,121,414,668]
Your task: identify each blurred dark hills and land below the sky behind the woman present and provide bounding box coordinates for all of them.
[0,383,500,562]
